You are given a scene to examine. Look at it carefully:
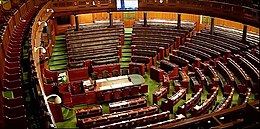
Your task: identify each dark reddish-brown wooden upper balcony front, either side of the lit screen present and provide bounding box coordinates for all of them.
[49,0,259,27]
